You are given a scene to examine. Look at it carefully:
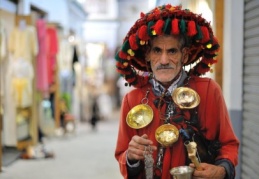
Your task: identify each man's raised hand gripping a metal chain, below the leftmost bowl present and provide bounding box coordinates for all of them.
[128,134,157,161]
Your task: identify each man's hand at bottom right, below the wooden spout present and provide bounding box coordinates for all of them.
[190,163,226,179]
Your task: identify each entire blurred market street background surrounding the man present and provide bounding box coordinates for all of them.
[0,0,259,179]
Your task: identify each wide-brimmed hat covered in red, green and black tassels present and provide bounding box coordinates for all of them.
[115,4,219,87]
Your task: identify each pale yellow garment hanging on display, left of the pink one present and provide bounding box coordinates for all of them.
[8,20,38,107]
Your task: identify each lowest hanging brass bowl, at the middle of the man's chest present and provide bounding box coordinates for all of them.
[155,124,179,147]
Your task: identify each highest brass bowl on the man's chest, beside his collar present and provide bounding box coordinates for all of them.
[172,87,200,109]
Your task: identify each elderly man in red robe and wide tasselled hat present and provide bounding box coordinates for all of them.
[115,4,239,179]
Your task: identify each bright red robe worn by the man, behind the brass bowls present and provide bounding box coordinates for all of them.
[115,77,239,179]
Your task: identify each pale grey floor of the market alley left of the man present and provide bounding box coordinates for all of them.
[0,115,122,179]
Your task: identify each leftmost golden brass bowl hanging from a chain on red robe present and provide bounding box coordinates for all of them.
[126,104,153,129]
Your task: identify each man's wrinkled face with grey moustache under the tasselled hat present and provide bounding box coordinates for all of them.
[147,36,187,85]
